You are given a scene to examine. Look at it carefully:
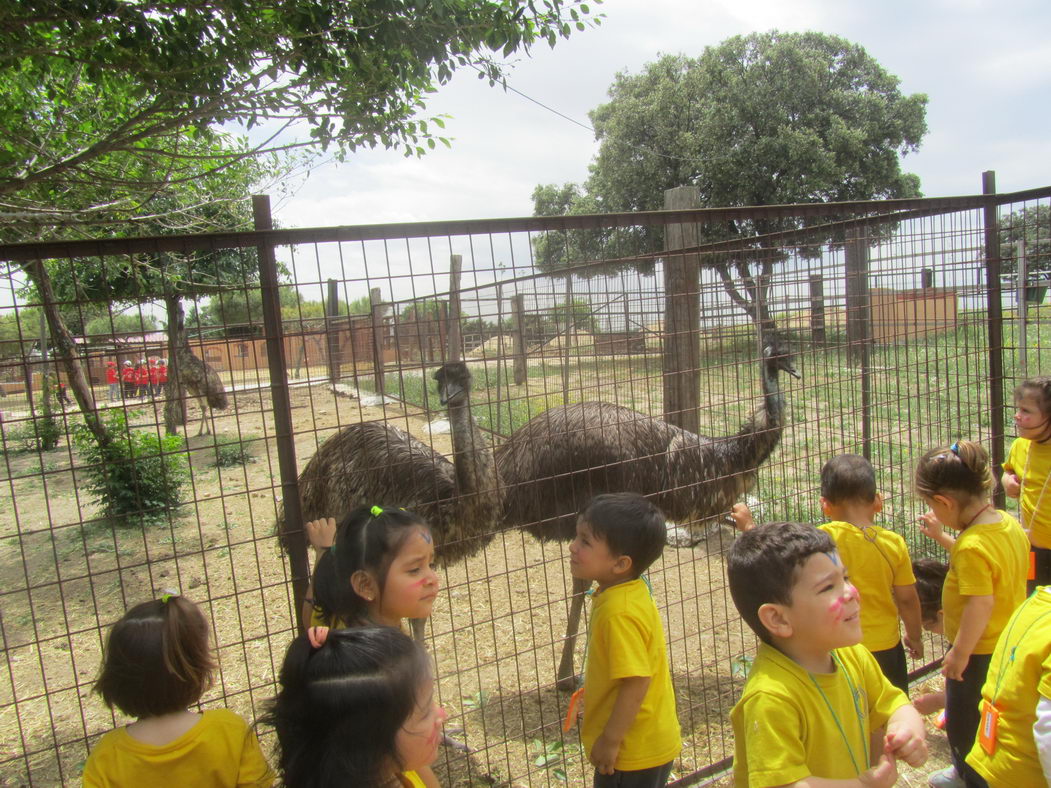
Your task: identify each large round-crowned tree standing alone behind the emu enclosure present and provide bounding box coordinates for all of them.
[534,32,927,324]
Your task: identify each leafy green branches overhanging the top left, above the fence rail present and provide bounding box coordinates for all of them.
[0,0,590,230]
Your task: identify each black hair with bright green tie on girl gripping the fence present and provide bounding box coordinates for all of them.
[314,506,427,626]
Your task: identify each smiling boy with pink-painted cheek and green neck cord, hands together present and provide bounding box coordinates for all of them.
[727,523,927,788]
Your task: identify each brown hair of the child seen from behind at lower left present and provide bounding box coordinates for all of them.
[94,596,215,718]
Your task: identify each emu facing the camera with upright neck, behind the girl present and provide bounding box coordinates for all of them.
[279,361,502,639]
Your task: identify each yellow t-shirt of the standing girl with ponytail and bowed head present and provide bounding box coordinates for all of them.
[942,512,1029,654]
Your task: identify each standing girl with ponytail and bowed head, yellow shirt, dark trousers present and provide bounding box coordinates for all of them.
[914,440,1029,788]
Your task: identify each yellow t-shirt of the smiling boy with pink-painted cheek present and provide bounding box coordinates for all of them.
[730,643,909,788]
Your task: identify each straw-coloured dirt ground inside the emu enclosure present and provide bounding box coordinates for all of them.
[0,374,946,788]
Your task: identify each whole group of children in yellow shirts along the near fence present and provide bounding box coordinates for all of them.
[84,379,1051,788]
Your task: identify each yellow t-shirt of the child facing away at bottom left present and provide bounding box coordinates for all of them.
[84,708,274,788]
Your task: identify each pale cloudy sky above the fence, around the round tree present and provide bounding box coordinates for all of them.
[274,0,1051,227]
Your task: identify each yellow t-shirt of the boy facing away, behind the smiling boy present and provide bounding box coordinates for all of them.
[819,520,916,651]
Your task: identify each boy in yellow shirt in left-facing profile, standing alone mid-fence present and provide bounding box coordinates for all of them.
[570,493,682,788]
